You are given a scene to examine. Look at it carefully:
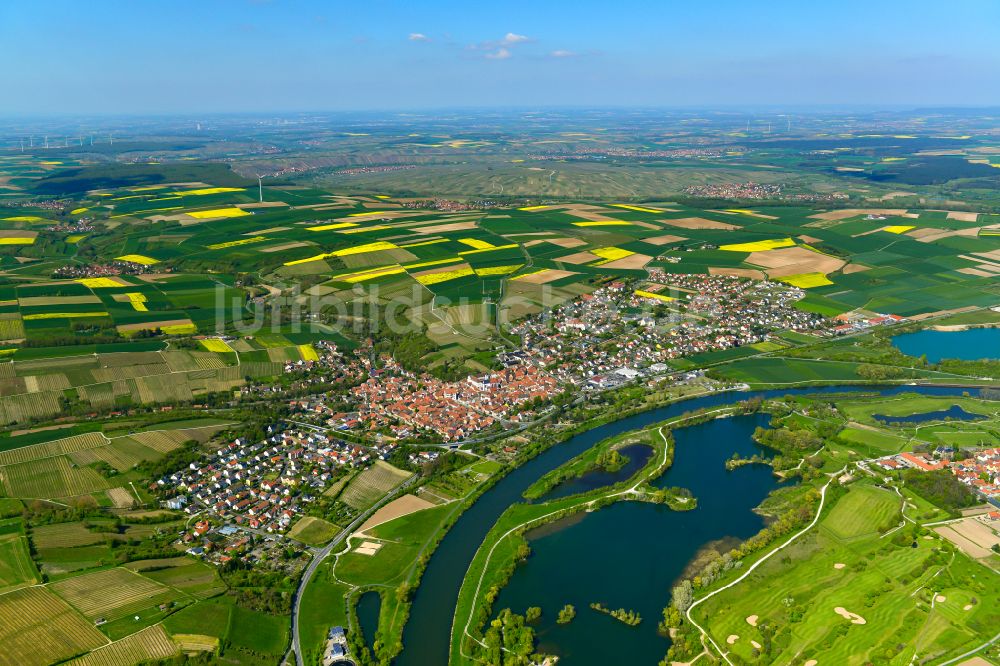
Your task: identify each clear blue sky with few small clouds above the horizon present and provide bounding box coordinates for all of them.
[0,0,1000,115]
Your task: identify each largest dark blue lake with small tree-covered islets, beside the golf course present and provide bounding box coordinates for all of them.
[493,414,778,666]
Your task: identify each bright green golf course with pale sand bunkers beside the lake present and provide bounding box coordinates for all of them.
[695,487,1000,664]
